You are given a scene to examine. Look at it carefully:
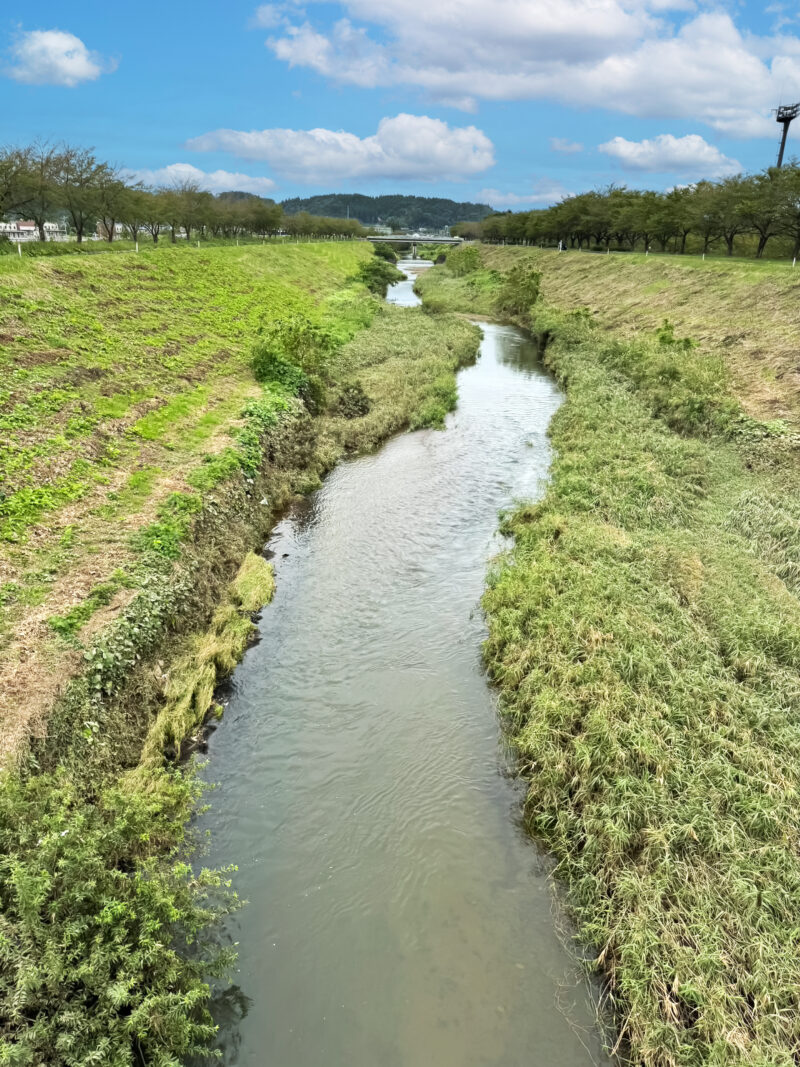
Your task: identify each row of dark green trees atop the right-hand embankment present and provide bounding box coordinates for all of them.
[452,160,800,259]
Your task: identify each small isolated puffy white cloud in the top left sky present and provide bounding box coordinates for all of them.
[5,30,116,89]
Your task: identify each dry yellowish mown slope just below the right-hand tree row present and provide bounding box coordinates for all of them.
[420,245,800,429]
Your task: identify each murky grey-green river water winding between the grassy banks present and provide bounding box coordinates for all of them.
[202,265,606,1067]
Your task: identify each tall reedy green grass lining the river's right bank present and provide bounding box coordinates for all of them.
[420,247,800,1067]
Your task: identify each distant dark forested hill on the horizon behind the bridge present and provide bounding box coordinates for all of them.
[281,193,492,229]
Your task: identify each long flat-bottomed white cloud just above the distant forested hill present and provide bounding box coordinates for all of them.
[187,114,494,184]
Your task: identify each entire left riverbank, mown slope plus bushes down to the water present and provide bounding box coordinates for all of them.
[0,243,478,1065]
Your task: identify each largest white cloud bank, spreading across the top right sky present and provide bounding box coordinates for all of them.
[267,0,800,137]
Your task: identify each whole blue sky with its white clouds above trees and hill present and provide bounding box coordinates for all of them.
[0,0,800,208]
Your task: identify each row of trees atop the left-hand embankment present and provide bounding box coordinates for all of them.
[0,142,366,243]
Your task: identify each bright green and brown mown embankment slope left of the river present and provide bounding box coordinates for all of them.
[0,243,377,749]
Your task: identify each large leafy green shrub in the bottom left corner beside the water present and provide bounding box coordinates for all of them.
[0,768,237,1067]
